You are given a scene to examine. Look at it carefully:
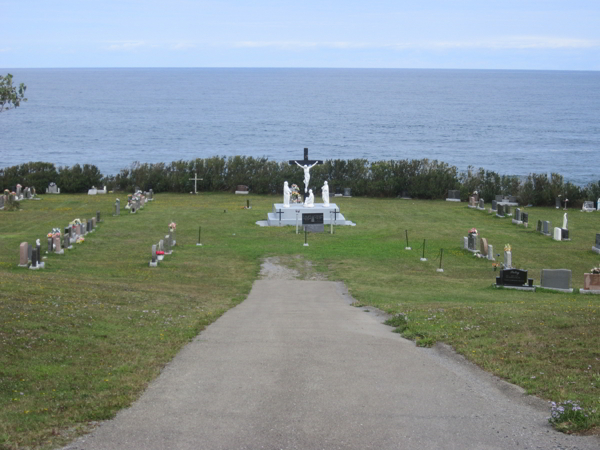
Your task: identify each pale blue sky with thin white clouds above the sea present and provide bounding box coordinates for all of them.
[0,0,600,70]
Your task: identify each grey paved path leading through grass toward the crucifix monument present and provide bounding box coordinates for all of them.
[66,279,600,450]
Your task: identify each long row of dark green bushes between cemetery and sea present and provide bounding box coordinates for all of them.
[0,156,600,206]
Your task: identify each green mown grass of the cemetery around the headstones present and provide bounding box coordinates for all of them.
[0,193,600,450]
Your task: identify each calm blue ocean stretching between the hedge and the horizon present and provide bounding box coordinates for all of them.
[0,68,600,185]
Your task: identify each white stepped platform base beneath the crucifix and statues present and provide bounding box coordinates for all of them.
[256,203,356,227]
